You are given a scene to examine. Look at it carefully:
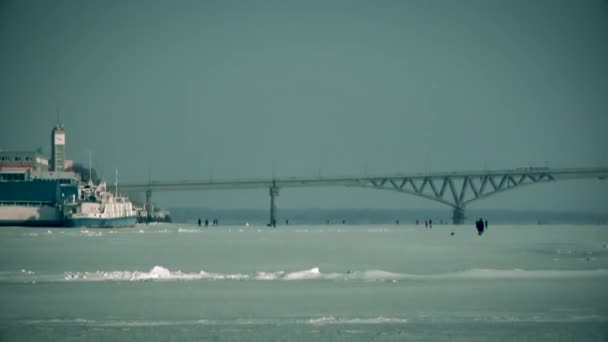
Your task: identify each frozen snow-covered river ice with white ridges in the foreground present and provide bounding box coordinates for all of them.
[0,224,608,341]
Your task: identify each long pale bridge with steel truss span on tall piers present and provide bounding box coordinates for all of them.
[120,167,608,226]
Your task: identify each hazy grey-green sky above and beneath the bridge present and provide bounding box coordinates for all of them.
[0,0,608,212]
